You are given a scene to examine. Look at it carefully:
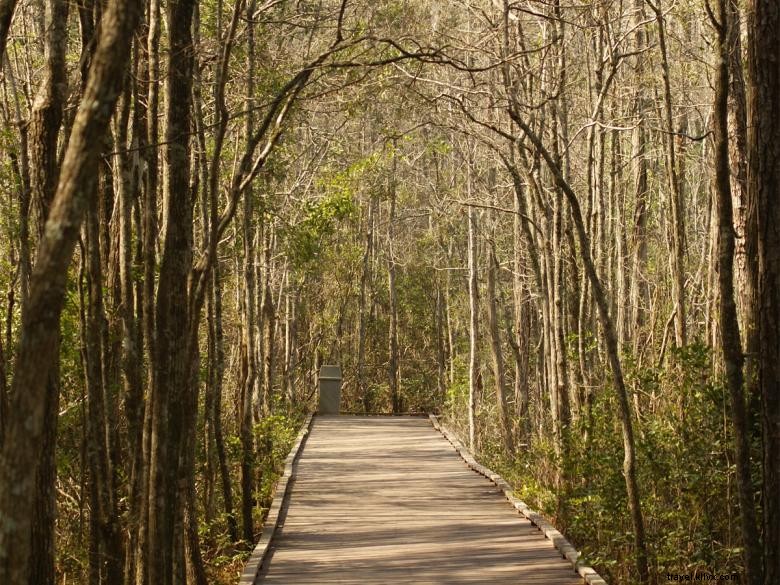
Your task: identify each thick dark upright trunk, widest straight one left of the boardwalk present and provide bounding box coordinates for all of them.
[148,0,195,585]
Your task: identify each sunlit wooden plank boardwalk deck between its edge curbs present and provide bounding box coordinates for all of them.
[259,416,583,585]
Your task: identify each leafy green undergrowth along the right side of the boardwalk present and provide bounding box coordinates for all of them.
[451,345,760,585]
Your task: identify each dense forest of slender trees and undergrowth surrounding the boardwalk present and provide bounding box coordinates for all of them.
[0,0,780,585]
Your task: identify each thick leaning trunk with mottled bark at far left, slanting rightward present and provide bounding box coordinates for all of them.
[0,0,139,583]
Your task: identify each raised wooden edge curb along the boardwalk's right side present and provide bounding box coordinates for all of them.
[428,414,607,585]
